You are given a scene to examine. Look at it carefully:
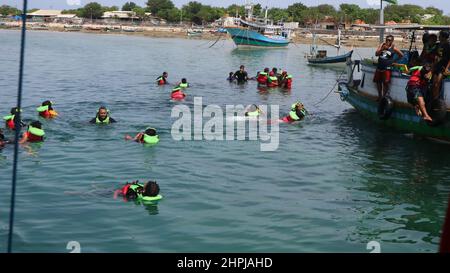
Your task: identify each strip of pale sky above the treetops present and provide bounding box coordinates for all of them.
[0,0,450,14]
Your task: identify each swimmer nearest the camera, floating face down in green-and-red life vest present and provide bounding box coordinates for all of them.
[114,180,162,201]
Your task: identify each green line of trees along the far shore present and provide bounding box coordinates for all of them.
[0,0,450,25]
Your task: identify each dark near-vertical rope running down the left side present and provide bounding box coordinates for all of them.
[8,0,28,253]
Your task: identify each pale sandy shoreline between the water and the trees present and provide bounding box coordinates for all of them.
[0,23,409,48]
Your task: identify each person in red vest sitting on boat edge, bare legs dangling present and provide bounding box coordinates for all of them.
[406,64,433,122]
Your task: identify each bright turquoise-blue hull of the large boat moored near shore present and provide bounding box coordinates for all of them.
[226,28,289,47]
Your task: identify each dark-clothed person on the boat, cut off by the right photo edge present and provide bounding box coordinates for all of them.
[432,30,450,100]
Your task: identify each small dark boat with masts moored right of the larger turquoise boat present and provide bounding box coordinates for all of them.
[306,29,353,65]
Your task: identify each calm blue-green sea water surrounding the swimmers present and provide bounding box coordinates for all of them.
[0,31,450,252]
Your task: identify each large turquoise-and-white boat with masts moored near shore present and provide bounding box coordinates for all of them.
[224,3,292,47]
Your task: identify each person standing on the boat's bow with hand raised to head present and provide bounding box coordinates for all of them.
[373,35,403,100]
